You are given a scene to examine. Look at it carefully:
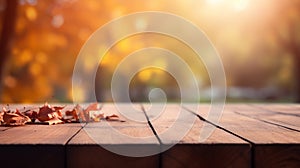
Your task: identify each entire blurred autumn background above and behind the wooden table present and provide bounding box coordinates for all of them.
[0,0,300,103]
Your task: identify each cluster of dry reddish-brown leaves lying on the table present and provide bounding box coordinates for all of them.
[0,103,123,126]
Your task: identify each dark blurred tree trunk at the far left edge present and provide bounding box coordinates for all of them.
[0,0,18,100]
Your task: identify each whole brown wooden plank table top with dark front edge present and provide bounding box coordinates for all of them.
[0,104,300,167]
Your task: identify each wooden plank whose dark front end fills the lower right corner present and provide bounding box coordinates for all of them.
[185,104,300,167]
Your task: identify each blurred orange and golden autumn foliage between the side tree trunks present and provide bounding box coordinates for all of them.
[0,0,300,103]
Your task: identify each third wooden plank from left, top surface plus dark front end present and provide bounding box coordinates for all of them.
[144,104,250,167]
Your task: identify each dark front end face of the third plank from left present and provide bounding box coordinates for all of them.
[162,143,251,167]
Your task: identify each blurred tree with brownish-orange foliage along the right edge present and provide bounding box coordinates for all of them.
[269,0,300,103]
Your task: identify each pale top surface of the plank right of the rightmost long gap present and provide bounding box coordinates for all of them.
[188,104,300,144]
